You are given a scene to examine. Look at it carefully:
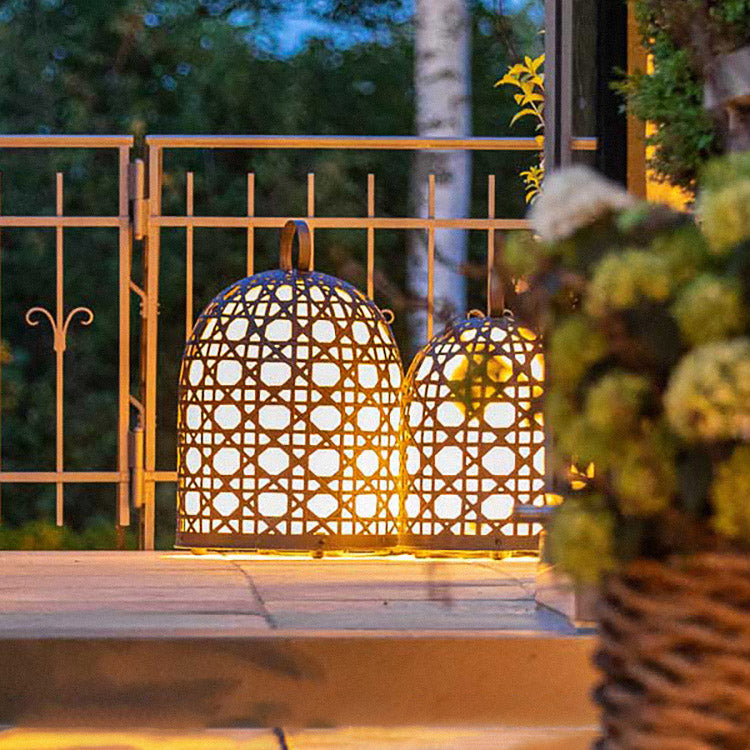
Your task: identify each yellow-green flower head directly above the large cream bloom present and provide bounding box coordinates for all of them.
[672,274,745,346]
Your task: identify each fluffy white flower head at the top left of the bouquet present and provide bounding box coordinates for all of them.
[529,165,635,242]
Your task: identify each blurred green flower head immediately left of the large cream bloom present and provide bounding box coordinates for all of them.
[586,371,651,435]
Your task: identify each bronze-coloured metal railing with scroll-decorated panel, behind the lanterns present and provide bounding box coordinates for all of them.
[0,135,597,549]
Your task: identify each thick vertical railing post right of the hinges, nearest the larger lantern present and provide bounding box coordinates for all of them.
[140,144,162,550]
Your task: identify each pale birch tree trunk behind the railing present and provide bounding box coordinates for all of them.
[407,0,471,350]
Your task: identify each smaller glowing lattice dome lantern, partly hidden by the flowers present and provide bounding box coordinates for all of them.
[402,314,545,551]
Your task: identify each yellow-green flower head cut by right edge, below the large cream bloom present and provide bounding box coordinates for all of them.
[711,445,750,542]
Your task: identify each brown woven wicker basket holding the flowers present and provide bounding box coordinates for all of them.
[595,554,750,750]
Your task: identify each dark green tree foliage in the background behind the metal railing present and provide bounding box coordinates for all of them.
[0,0,533,544]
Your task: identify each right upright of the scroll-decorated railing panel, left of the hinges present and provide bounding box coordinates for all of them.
[115,146,133,546]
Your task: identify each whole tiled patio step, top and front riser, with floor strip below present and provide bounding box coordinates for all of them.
[0,552,595,750]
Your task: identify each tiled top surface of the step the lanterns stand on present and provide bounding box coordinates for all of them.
[0,552,573,638]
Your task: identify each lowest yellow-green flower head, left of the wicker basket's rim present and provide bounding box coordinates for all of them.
[549,497,615,583]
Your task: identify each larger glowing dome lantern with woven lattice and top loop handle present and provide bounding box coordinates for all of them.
[177,221,402,550]
